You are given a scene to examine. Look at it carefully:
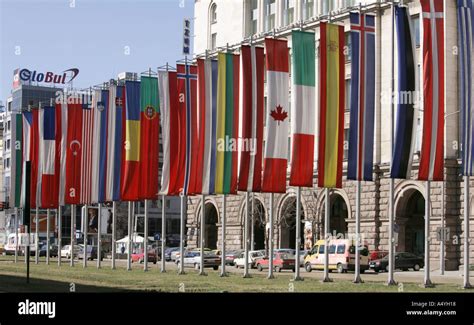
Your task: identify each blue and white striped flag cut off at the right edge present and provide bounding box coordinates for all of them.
[457,0,474,176]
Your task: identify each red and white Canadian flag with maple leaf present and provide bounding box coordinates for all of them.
[262,38,289,193]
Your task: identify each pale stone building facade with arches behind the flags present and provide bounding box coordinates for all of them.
[187,0,474,270]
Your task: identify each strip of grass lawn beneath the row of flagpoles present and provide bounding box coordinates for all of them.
[0,258,465,292]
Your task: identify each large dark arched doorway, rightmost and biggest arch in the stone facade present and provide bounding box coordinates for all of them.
[395,189,425,255]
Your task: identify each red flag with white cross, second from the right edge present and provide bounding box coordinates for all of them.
[418,0,444,181]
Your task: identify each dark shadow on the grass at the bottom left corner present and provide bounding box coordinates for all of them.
[0,274,136,293]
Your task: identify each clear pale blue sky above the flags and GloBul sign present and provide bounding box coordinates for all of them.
[0,0,194,103]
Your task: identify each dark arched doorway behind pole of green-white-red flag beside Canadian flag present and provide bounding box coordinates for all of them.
[277,196,304,249]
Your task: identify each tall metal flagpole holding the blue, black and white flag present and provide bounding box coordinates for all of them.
[387,2,396,285]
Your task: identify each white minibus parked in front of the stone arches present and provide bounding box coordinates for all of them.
[304,239,369,273]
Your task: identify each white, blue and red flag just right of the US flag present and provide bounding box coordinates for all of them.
[90,90,109,203]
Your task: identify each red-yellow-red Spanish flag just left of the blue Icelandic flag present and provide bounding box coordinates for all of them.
[318,22,345,188]
